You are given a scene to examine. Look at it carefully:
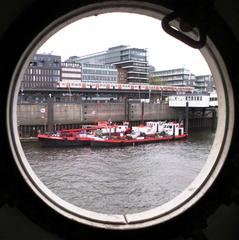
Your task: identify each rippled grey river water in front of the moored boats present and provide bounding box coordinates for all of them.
[23,130,214,214]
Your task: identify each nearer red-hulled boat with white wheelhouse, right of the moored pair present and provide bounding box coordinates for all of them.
[90,122,188,147]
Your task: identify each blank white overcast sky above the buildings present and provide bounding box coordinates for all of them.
[37,13,210,75]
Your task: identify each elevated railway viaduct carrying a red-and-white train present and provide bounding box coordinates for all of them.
[18,81,193,104]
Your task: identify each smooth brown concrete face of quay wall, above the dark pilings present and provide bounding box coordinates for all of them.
[17,102,181,126]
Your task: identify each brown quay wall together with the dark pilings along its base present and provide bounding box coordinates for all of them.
[17,101,216,137]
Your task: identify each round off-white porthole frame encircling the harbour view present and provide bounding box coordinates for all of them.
[1,1,235,234]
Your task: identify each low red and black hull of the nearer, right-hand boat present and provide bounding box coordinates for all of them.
[90,134,188,147]
